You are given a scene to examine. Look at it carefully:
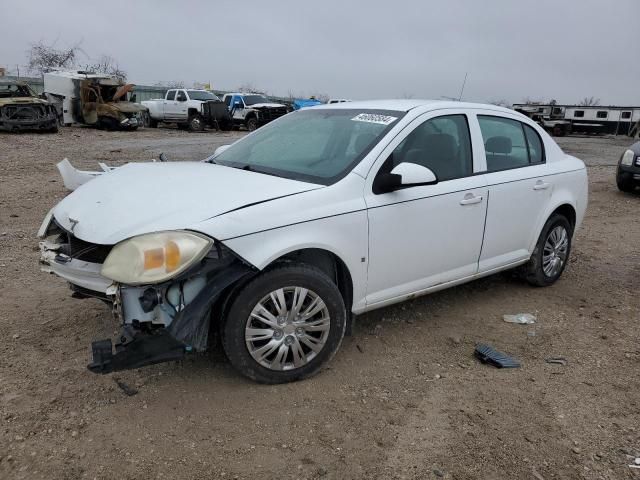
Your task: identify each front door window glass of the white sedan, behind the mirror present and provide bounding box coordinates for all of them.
[383,115,473,182]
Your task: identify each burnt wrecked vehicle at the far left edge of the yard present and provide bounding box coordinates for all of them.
[0,80,58,132]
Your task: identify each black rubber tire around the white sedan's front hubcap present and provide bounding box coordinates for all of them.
[222,263,347,384]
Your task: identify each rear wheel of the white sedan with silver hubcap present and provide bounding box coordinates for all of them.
[524,213,573,287]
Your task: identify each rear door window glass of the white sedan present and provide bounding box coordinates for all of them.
[478,115,544,172]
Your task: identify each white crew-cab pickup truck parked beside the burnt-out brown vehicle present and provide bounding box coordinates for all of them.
[141,88,232,132]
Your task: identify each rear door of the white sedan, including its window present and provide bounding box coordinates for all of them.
[476,111,553,273]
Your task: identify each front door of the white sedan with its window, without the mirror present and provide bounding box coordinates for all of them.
[365,111,487,306]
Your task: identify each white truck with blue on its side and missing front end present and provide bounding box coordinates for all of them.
[223,93,287,132]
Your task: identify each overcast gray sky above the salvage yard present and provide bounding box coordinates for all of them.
[0,0,640,105]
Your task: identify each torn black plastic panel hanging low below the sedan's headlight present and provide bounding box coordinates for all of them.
[87,330,185,373]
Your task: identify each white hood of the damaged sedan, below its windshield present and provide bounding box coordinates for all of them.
[53,162,322,245]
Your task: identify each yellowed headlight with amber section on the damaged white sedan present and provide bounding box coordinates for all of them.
[102,231,213,285]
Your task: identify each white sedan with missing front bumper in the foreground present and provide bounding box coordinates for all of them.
[39,100,587,383]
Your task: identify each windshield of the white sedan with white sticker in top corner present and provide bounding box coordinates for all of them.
[210,109,404,185]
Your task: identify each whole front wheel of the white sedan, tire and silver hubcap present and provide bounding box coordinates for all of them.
[222,264,347,384]
